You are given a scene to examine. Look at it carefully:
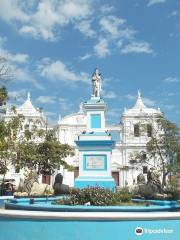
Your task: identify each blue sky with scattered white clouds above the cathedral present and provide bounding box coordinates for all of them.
[0,0,180,125]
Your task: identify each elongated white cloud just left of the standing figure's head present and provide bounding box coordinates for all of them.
[38,58,90,84]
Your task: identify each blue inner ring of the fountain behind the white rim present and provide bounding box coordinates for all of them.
[5,198,180,212]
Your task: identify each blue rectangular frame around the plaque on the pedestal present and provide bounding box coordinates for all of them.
[83,154,107,171]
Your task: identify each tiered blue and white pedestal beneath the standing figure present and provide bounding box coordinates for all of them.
[75,98,116,190]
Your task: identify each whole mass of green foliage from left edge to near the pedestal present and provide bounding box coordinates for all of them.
[0,111,74,175]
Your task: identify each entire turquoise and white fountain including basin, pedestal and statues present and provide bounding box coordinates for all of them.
[0,70,180,240]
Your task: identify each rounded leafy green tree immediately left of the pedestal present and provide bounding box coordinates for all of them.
[13,132,74,175]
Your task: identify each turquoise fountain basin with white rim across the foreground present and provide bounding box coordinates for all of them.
[0,199,180,240]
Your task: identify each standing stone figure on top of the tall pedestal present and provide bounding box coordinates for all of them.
[92,68,101,97]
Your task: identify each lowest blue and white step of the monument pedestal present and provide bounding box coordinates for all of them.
[74,177,116,191]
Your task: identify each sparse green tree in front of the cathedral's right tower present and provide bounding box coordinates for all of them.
[130,116,180,189]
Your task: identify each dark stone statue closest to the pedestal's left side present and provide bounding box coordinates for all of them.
[53,173,70,195]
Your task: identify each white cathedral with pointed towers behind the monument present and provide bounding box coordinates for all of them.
[4,69,162,187]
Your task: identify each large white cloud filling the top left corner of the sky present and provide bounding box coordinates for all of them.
[0,0,92,41]
